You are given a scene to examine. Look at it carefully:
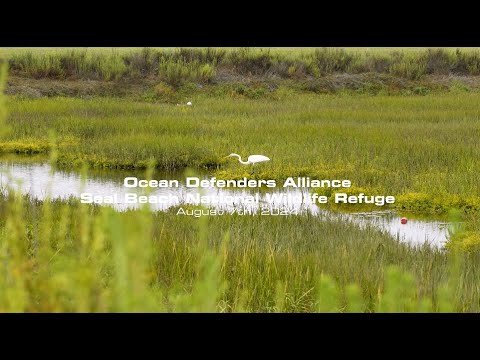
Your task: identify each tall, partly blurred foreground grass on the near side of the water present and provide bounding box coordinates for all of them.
[0,188,480,312]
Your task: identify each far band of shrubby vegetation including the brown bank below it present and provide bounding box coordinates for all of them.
[6,48,480,99]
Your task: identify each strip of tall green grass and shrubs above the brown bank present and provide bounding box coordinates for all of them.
[8,48,480,85]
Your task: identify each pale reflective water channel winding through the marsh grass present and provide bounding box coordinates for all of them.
[0,162,448,247]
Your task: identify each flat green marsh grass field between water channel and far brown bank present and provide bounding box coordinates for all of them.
[0,93,480,213]
